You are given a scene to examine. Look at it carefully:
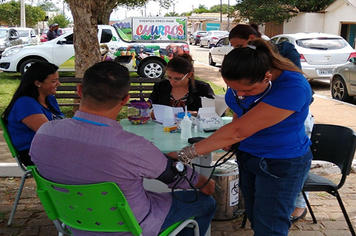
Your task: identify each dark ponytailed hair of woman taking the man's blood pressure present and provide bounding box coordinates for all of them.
[221,39,303,84]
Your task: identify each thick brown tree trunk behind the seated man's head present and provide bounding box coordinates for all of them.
[68,0,109,78]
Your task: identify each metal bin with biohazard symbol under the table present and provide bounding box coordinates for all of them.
[212,161,244,220]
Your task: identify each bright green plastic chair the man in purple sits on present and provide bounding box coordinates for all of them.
[28,166,199,236]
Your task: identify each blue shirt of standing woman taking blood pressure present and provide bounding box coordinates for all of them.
[225,71,312,159]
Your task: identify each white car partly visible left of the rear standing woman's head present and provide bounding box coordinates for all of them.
[209,37,234,66]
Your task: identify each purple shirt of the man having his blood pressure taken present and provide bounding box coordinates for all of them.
[30,111,198,236]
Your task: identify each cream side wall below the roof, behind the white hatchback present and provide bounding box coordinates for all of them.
[283,13,324,34]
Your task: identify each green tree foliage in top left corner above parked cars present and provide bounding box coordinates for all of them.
[0,1,46,27]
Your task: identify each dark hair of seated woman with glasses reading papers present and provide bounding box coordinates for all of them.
[166,53,195,86]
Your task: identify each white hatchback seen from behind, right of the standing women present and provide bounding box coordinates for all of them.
[271,33,356,80]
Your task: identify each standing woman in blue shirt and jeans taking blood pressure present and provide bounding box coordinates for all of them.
[174,39,312,236]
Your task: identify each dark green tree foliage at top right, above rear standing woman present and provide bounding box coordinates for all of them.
[236,0,335,24]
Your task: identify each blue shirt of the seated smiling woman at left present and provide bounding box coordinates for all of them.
[7,95,64,151]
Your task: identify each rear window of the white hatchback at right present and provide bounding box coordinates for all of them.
[296,38,347,50]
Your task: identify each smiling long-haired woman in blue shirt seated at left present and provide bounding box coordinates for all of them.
[2,61,64,166]
